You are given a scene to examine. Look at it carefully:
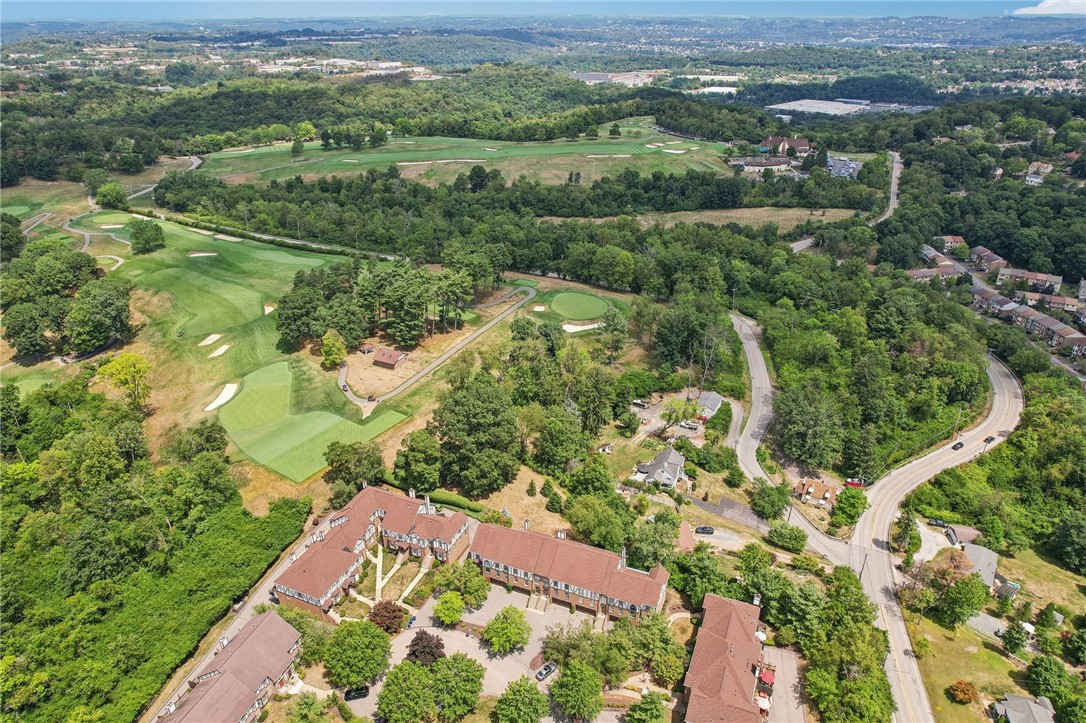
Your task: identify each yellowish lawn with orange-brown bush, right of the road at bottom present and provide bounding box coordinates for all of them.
[907,613,1028,723]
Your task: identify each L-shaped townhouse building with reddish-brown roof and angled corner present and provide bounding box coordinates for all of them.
[272,486,468,617]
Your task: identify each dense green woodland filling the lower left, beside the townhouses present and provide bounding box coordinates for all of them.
[0,373,310,721]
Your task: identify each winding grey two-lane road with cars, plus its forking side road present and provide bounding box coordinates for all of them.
[732,315,1025,723]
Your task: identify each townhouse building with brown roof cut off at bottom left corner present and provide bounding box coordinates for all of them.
[159,611,302,723]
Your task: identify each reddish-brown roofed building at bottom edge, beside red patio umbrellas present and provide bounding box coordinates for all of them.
[683,594,772,723]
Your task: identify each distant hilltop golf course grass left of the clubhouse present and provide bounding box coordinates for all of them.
[203,118,727,183]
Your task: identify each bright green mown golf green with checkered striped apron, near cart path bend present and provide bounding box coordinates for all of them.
[218,362,405,482]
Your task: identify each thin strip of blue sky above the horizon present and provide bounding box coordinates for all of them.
[0,0,1086,22]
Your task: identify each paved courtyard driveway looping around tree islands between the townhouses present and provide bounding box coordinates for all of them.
[348,585,599,721]
